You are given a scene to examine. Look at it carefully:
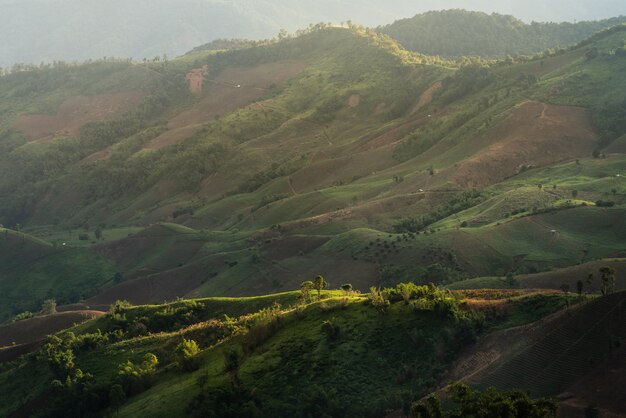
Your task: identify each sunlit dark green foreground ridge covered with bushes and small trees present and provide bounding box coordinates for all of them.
[0,284,596,417]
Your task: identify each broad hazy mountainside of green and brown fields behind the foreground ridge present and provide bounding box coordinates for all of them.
[0,21,626,319]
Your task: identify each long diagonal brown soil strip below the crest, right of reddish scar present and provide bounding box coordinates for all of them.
[147,61,306,149]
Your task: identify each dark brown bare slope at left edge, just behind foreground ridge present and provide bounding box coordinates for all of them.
[0,311,103,347]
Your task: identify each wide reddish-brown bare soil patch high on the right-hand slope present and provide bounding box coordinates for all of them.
[451,102,598,188]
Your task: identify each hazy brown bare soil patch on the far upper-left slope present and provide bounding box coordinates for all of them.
[13,91,144,141]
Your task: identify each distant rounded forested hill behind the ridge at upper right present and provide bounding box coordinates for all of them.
[378,10,626,57]
